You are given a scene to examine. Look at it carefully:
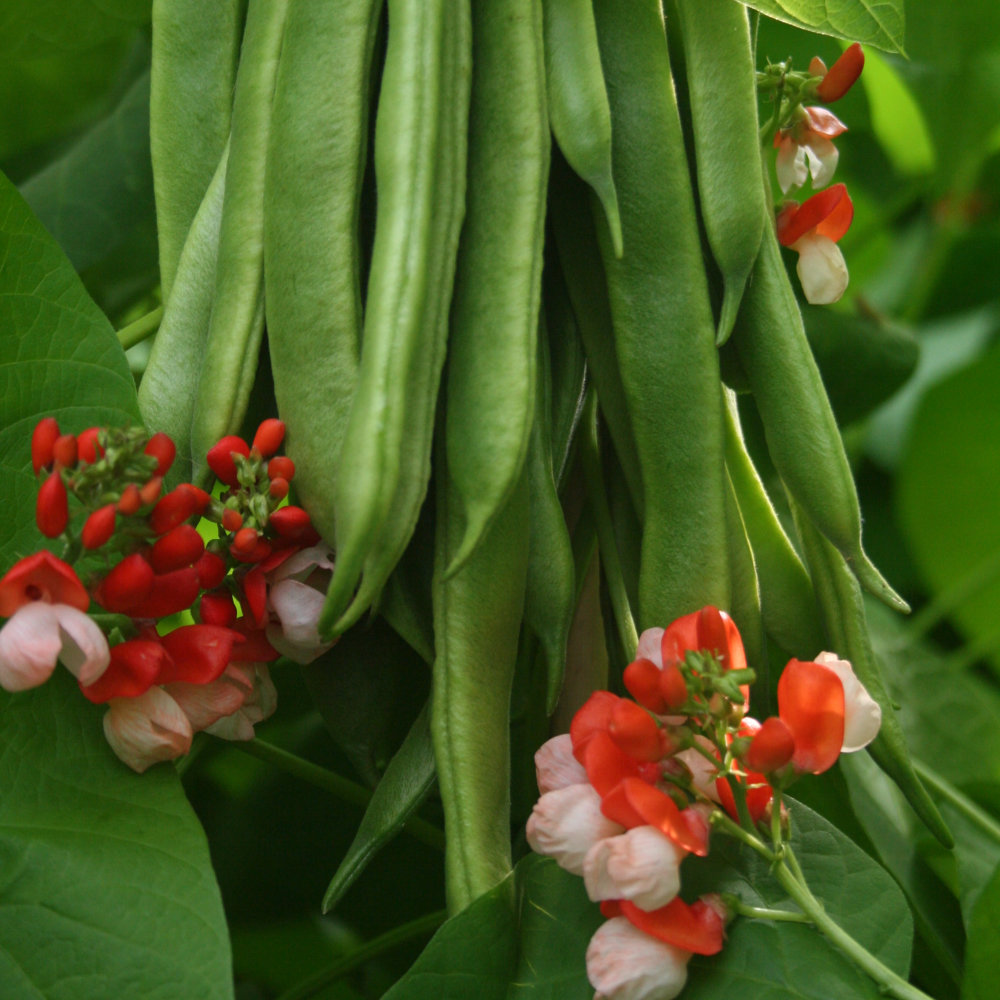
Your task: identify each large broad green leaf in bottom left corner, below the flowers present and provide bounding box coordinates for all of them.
[0,668,232,1000]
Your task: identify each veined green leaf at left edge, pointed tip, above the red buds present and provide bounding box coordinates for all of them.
[0,169,139,570]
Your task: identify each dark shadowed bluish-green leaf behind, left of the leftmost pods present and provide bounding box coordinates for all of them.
[21,72,156,271]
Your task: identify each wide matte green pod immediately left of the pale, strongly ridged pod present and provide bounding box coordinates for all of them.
[264,0,382,540]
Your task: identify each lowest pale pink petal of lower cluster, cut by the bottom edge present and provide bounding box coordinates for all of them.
[587,917,691,1000]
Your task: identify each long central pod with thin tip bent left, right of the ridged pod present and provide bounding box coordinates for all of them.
[445,0,550,572]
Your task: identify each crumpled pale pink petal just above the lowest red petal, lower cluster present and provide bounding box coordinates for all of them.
[583,826,687,910]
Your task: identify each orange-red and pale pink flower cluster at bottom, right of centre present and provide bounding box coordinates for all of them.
[527,607,881,1000]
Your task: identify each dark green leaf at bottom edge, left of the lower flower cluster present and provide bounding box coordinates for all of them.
[383,855,601,1000]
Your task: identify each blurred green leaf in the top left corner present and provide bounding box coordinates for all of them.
[0,0,151,59]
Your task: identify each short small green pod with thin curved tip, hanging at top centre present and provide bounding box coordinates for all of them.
[542,0,622,257]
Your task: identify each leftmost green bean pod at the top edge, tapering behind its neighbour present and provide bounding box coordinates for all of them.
[149,0,243,298]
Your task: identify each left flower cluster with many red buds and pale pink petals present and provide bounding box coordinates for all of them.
[0,417,333,772]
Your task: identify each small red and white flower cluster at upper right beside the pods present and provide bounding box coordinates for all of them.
[761,42,864,304]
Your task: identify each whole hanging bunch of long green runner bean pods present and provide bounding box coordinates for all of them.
[140,0,946,908]
